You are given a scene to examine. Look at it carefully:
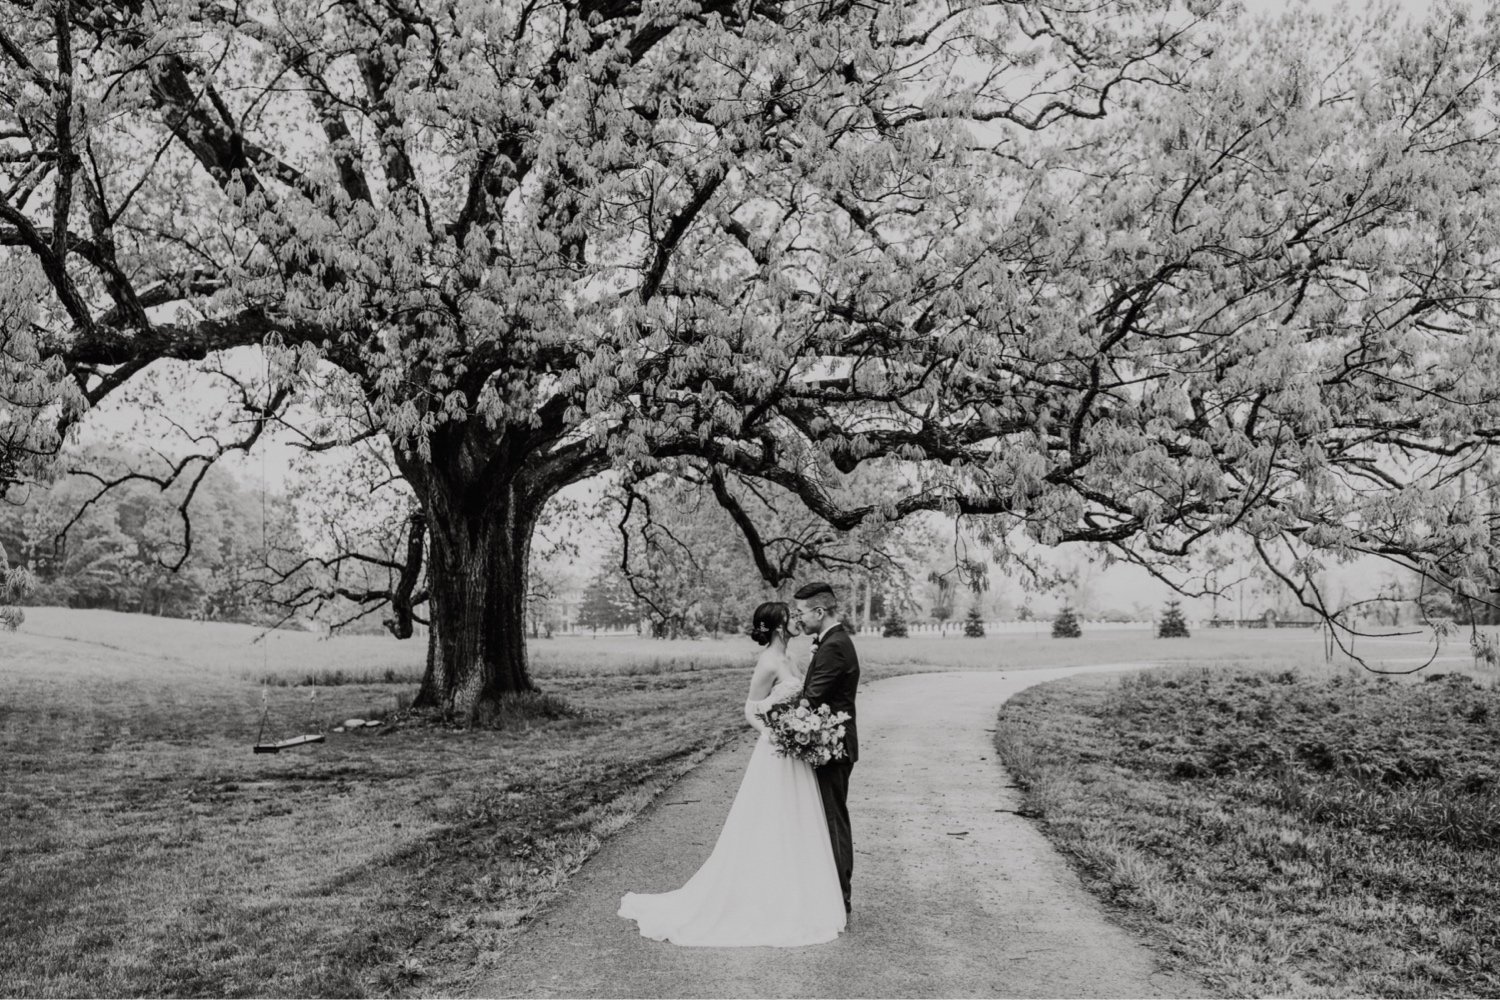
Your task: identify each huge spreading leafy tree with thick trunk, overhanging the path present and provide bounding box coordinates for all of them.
[0,0,1497,718]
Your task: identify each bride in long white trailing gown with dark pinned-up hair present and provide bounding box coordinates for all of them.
[620,601,845,948]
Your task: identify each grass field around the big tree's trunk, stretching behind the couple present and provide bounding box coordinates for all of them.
[0,609,1476,996]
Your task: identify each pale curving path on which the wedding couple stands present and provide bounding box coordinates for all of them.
[476,664,1205,997]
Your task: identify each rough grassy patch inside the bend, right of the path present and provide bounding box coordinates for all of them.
[996,666,1500,997]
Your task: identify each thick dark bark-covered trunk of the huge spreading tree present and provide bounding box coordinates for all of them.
[417,467,542,724]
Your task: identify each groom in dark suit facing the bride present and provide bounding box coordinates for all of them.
[792,583,860,913]
